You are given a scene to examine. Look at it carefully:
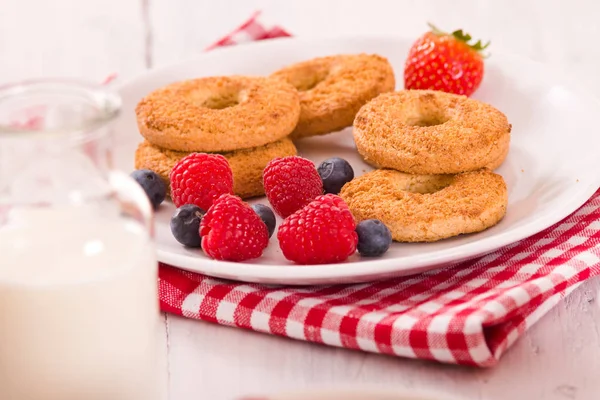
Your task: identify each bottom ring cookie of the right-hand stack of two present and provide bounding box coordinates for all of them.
[340,169,508,242]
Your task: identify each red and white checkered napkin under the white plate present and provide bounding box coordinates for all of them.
[159,15,600,366]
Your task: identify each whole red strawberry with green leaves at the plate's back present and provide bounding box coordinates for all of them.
[404,25,490,96]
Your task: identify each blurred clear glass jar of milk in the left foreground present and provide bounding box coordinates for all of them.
[0,81,160,400]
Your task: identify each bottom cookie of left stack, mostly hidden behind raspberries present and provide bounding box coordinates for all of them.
[135,138,297,199]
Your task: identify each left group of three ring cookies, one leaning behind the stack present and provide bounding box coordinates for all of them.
[135,54,395,198]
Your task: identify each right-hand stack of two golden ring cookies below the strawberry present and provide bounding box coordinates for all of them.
[340,90,511,242]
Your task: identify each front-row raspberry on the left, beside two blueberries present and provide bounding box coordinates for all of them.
[200,194,269,261]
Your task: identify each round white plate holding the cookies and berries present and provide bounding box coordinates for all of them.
[116,37,600,284]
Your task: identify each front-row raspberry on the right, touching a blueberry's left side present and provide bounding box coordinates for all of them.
[277,194,358,264]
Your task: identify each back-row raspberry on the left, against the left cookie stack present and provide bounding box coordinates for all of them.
[169,153,233,210]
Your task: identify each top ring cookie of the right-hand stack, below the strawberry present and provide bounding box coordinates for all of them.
[354,90,511,174]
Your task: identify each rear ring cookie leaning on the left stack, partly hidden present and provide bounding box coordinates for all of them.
[271,54,396,139]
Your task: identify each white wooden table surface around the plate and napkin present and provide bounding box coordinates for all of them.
[0,0,600,400]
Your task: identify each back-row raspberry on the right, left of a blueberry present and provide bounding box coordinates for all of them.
[263,156,323,218]
